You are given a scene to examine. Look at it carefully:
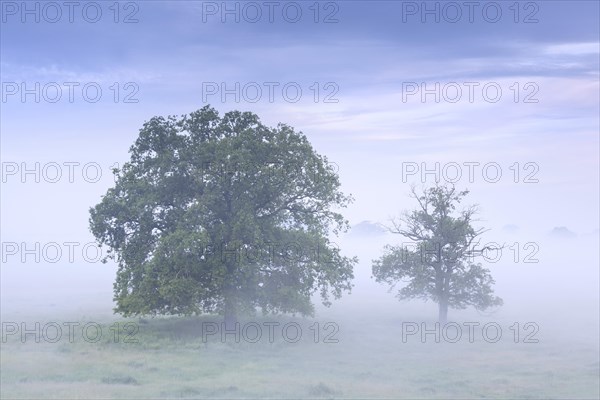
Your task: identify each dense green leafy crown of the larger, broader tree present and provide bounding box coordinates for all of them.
[90,106,356,316]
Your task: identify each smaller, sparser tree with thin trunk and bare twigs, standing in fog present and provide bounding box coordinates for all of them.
[373,185,503,324]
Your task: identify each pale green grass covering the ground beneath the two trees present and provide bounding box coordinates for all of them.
[0,315,600,399]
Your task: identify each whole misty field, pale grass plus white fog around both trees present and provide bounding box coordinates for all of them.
[0,237,600,399]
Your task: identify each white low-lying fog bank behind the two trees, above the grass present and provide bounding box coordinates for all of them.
[1,222,600,345]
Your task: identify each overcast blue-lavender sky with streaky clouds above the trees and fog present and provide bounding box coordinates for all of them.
[0,1,599,272]
